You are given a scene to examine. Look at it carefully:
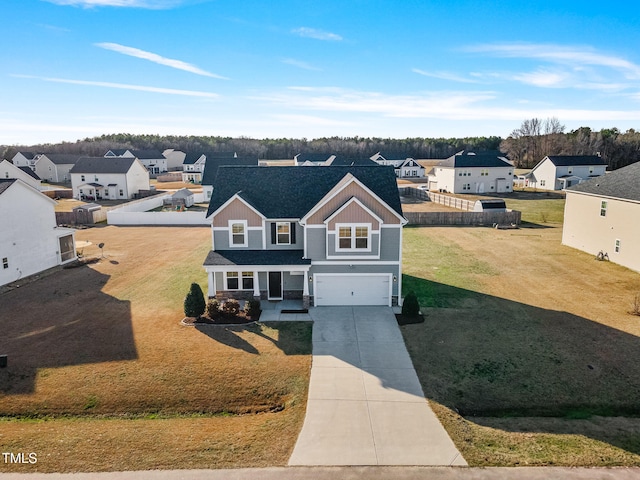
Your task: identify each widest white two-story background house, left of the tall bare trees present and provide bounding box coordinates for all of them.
[429,152,513,193]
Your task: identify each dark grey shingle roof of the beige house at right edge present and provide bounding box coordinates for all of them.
[567,162,640,202]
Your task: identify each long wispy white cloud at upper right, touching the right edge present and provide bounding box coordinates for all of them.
[464,43,640,79]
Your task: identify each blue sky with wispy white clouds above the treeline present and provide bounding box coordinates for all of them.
[0,0,640,145]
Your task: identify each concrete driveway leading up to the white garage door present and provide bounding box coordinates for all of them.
[289,307,467,466]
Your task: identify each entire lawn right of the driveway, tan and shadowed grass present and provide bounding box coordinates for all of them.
[402,226,640,466]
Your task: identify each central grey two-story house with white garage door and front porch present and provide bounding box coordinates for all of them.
[204,166,407,306]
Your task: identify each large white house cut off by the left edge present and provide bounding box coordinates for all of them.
[0,179,76,286]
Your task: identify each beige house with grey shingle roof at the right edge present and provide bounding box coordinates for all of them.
[562,162,640,272]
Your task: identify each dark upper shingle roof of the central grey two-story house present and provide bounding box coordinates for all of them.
[207,166,402,218]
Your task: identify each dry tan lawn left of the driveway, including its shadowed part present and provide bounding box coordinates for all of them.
[0,226,311,471]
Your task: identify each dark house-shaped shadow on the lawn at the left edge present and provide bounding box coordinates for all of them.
[0,266,138,400]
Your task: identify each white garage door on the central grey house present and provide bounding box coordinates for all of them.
[314,273,391,306]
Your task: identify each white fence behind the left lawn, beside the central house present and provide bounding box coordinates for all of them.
[107,193,211,226]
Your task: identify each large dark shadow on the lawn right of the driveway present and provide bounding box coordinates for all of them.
[402,276,640,454]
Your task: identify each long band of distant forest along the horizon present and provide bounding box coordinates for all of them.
[0,118,640,170]
